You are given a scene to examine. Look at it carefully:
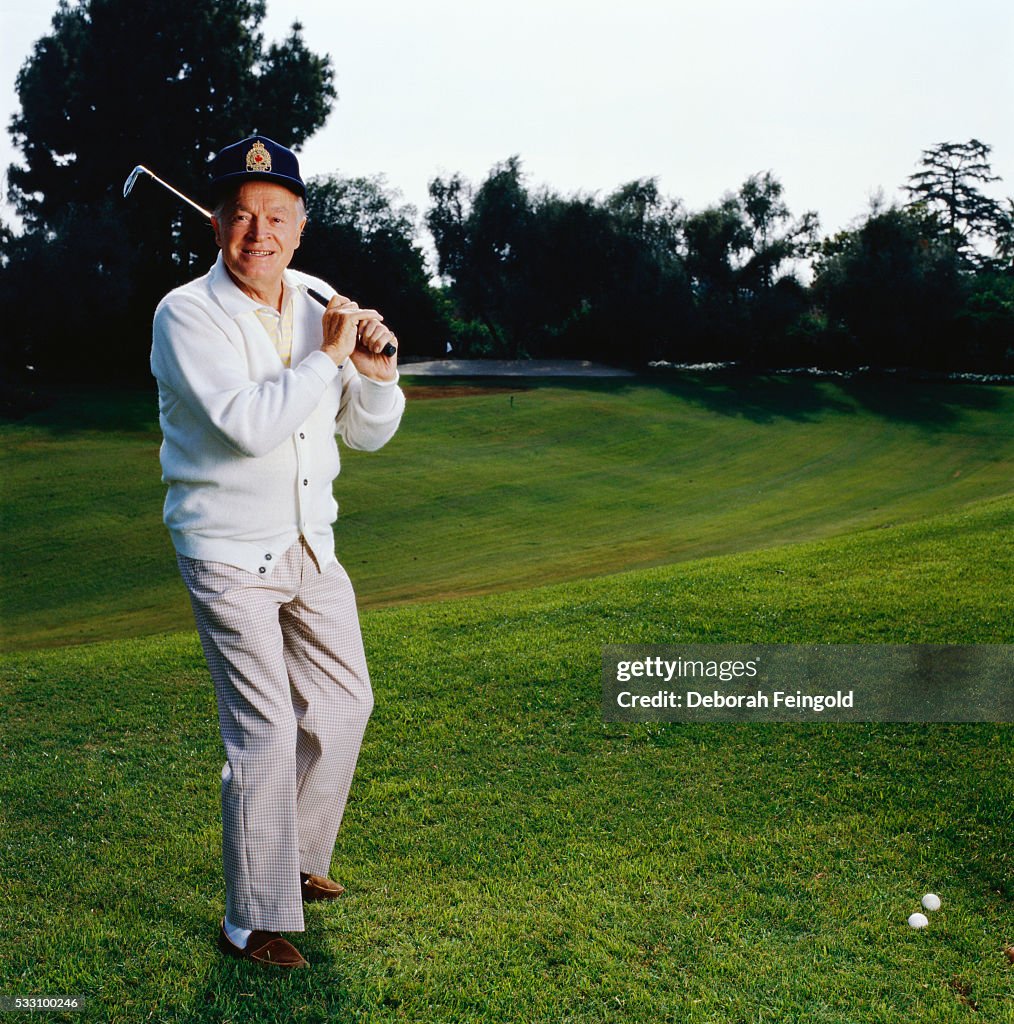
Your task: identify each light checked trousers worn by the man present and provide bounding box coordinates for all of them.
[177,539,373,932]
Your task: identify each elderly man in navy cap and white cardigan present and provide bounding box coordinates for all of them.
[152,136,405,967]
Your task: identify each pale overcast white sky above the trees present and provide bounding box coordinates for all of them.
[0,0,1014,241]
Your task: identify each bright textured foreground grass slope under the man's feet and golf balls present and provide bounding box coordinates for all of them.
[0,498,1014,1024]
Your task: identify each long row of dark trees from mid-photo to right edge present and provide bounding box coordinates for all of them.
[434,152,1014,372]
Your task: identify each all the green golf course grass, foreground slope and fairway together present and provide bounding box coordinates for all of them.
[0,376,1014,1024]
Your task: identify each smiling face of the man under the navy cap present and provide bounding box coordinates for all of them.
[212,181,306,301]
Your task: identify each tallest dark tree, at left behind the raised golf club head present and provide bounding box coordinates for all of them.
[4,0,335,381]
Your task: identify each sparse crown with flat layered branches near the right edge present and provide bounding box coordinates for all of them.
[905,138,1011,268]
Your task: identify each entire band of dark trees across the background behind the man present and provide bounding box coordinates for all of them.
[0,0,1014,406]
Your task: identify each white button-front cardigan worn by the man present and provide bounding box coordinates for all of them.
[152,254,405,575]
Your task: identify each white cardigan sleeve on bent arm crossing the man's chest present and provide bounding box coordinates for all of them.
[152,298,342,458]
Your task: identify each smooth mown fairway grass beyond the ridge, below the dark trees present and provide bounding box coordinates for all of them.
[0,375,1014,648]
